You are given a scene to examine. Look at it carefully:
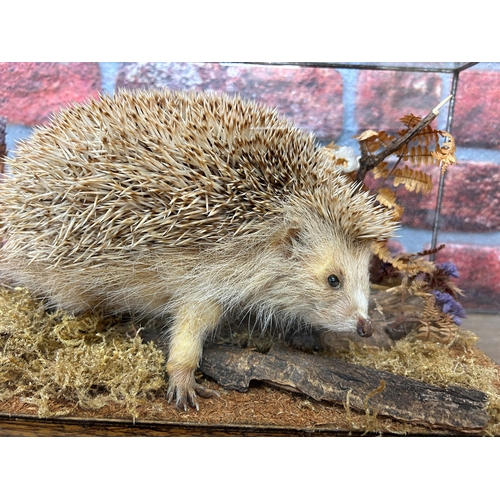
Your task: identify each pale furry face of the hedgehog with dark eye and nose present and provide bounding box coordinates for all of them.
[274,221,372,337]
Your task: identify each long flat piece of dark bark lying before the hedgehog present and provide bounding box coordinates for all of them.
[201,345,489,430]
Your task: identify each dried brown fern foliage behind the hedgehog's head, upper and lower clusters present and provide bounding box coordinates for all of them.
[357,108,464,342]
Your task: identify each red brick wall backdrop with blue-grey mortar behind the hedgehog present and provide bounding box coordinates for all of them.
[0,62,500,312]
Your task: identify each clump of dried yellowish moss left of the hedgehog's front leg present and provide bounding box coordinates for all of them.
[0,288,165,418]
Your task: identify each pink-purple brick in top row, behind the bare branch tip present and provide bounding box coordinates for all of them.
[356,71,442,133]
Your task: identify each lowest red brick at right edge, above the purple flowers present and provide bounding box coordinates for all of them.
[436,241,500,311]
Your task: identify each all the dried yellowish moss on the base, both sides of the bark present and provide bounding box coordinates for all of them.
[0,287,500,435]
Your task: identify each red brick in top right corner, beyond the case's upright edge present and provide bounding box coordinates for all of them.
[452,69,500,149]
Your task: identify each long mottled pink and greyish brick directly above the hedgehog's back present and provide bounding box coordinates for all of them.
[117,63,344,141]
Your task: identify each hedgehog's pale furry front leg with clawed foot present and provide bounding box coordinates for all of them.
[167,303,221,411]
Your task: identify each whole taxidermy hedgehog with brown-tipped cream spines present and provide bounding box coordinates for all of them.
[0,89,396,410]
